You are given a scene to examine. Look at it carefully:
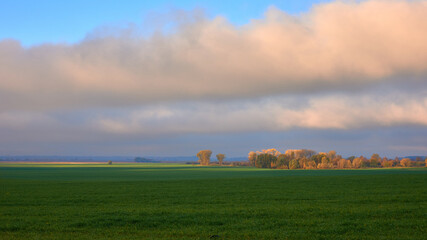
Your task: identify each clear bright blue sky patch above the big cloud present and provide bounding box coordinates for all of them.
[0,0,325,46]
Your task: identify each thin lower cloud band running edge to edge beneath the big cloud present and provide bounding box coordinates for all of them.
[0,91,427,137]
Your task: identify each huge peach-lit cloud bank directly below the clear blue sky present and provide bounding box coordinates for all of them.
[0,0,427,111]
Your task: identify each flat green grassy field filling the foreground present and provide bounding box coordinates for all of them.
[0,164,427,239]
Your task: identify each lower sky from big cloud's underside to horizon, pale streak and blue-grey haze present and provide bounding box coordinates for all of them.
[0,90,427,157]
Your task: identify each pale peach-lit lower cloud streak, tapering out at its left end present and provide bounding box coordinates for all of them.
[94,94,427,135]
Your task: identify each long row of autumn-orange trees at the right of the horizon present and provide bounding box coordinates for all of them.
[248,148,427,169]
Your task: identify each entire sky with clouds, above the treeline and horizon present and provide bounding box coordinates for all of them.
[0,0,427,157]
